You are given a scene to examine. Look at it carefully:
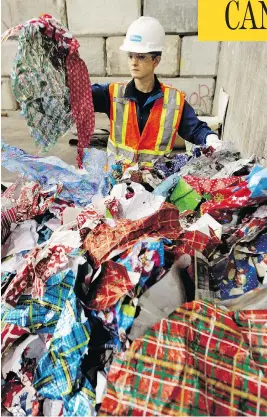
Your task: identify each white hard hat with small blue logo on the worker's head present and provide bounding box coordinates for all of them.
[120,16,165,53]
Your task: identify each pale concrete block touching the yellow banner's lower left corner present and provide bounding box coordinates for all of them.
[180,36,219,76]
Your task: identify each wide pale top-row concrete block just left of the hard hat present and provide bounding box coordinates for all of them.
[67,0,141,36]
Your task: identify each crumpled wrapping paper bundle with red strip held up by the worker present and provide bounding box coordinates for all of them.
[1,14,95,167]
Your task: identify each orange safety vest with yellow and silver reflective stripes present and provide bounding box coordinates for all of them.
[107,83,185,165]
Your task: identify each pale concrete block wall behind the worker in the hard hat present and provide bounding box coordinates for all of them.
[2,0,220,115]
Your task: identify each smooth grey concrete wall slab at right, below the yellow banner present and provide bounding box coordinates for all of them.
[213,42,267,159]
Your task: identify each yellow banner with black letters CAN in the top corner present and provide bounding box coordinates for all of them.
[198,0,267,42]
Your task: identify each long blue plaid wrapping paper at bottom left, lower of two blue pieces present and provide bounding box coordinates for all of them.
[33,290,91,415]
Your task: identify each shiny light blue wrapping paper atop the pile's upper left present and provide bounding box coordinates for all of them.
[1,142,109,206]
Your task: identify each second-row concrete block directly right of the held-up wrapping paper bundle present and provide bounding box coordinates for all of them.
[77,37,106,76]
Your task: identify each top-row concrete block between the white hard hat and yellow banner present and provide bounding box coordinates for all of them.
[144,0,198,34]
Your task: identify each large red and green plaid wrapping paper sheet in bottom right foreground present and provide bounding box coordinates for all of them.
[99,301,267,416]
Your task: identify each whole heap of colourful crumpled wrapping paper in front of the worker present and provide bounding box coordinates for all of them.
[1,138,267,416]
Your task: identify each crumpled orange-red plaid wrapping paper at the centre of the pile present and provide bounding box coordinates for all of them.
[84,203,181,267]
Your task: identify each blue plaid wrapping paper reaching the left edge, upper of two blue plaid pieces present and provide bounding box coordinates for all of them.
[2,270,75,334]
